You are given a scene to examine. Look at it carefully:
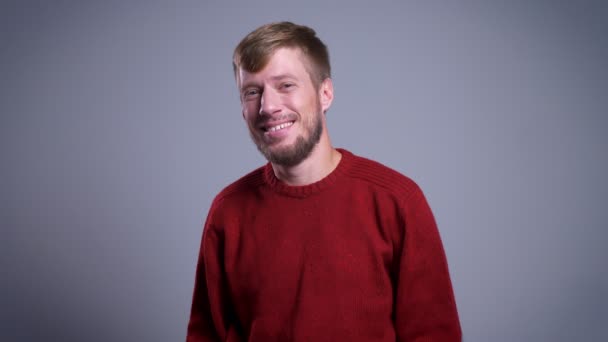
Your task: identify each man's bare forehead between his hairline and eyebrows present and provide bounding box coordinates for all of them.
[237,48,310,86]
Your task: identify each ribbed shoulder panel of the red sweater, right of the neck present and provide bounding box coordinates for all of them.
[345,151,421,199]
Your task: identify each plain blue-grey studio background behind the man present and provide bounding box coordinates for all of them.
[0,1,608,341]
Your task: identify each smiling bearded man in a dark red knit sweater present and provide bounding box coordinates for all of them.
[187,22,461,342]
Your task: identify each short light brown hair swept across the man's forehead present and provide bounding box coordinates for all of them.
[232,21,331,87]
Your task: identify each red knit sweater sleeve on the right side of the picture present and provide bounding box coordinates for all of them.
[395,187,462,342]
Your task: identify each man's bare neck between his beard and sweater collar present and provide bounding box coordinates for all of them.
[272,134,342,186]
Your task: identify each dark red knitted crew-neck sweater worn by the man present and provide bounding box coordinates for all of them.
[187,149,461,342]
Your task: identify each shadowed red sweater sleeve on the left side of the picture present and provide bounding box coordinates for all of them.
[186,224,230,342]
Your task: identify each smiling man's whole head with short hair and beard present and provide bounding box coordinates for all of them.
[233,22,333,166]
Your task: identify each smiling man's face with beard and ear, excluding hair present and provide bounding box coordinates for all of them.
[237,48,331,166]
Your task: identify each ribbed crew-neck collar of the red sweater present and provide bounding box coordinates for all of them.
[264,148,354,198]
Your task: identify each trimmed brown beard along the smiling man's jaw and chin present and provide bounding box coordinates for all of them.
[249,105,323,167]
